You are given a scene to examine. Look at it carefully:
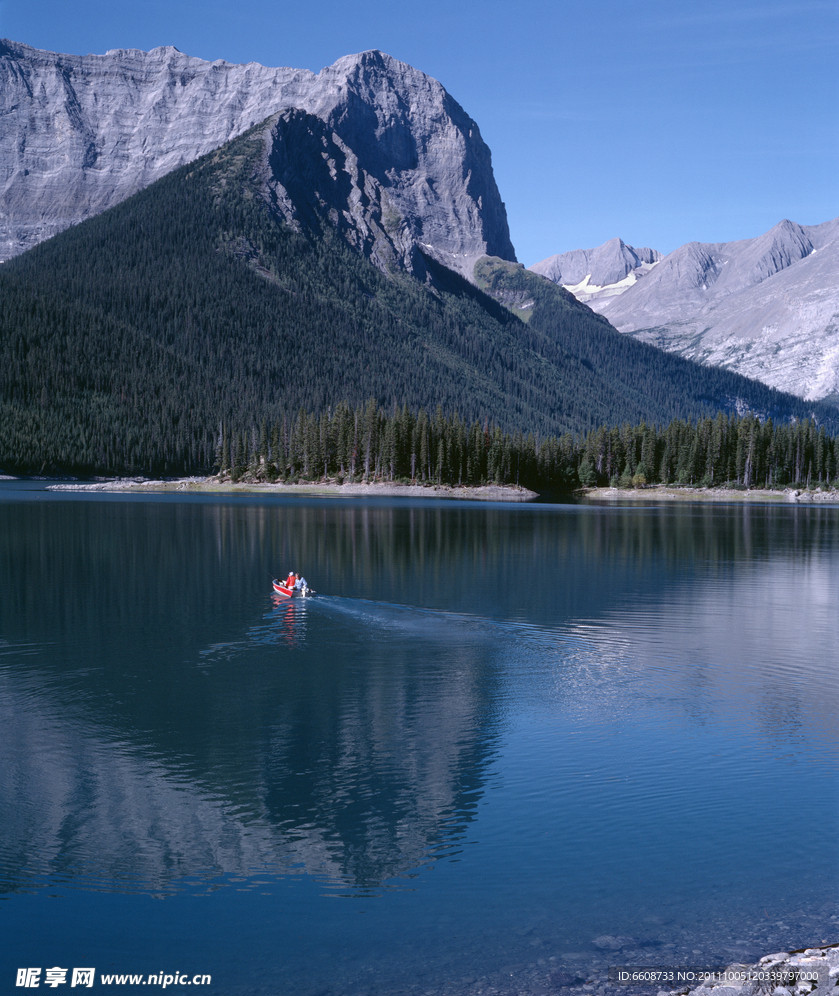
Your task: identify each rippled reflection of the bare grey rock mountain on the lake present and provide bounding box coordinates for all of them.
[0,636,498,892]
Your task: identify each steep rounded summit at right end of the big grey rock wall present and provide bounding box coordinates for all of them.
[288,50,515,279]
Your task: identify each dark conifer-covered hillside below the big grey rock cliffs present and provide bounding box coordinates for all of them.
[0,118,827,474]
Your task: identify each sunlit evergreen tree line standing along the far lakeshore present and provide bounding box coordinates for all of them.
[217,399,839,493]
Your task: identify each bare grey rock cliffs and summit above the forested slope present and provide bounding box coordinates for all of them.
[0,41,515,273]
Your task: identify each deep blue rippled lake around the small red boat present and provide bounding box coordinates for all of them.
[0,482,839,996]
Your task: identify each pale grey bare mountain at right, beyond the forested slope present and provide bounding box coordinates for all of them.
[534,218,839,400]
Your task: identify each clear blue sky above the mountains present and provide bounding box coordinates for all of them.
[0,0,839,265]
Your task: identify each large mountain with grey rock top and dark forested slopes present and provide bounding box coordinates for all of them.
[0,43,836,482]
